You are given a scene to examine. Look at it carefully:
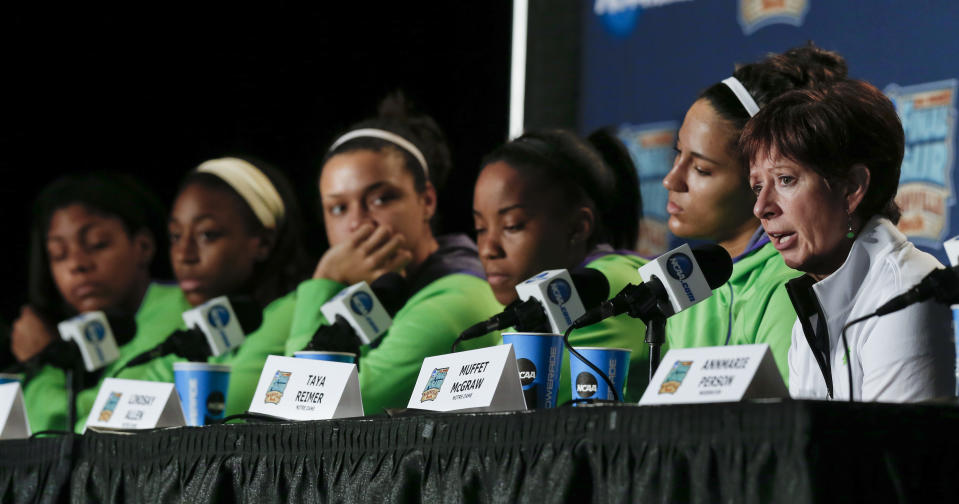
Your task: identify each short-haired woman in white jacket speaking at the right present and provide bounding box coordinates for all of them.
[740,80,956,402]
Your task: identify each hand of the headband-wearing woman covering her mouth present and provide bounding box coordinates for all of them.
[313,224,413,285]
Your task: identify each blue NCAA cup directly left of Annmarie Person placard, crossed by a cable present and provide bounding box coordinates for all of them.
[569,347,631,400]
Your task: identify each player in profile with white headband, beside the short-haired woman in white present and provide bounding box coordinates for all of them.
[663,44,846,379]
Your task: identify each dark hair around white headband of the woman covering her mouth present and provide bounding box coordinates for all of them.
[317,91,453,194]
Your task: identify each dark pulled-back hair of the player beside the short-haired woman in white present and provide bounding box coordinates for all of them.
[699,42,848,158]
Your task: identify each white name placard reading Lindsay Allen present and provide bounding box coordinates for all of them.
[84,378,186,431]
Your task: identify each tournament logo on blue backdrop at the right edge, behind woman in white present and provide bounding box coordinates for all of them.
[885,79,957,248]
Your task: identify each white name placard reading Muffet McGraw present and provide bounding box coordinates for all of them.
[407,345,526,412]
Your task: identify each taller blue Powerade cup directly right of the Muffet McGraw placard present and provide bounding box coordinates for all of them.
[503,333,563,409]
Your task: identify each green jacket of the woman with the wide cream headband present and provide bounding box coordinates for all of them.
[131,292,296,416]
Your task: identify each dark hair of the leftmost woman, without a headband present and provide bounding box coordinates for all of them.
[27,172,166,321]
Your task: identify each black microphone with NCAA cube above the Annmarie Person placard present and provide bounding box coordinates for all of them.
[573,244,733,329]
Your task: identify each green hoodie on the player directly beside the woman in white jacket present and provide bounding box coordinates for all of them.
[666,239,801,384]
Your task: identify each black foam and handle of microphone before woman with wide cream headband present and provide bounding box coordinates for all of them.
[114,296,263,370]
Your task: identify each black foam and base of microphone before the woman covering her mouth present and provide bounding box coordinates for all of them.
[303,272,409,353]
